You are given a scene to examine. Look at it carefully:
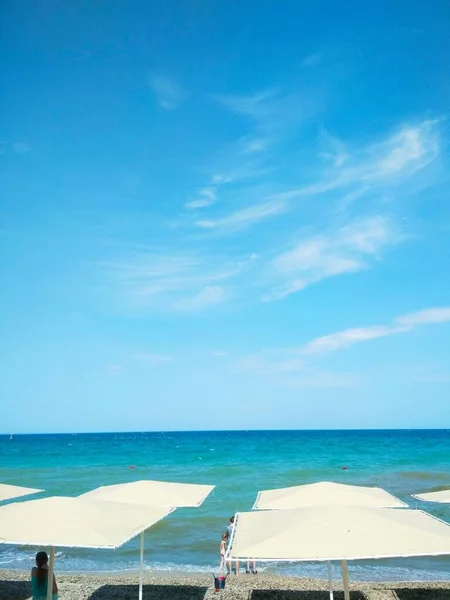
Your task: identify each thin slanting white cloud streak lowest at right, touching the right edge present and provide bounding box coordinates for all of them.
[301,307,450,354]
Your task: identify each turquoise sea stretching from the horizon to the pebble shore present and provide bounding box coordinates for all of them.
[0,430,450,580]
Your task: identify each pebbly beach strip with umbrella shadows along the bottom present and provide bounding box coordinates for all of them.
[0,571,450,600]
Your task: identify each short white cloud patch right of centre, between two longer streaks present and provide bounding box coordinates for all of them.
[264,216,400,300]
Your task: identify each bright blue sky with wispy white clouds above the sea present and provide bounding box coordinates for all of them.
[0,0,450,433]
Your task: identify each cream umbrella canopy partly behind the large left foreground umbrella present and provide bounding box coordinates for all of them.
[79,480,214,507]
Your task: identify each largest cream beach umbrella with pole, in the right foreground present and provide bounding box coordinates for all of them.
[226,506,450,600]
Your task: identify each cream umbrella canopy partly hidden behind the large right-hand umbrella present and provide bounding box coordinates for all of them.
[253,481,408,510]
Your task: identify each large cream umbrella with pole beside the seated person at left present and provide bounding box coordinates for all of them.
[0,496,174,600]
